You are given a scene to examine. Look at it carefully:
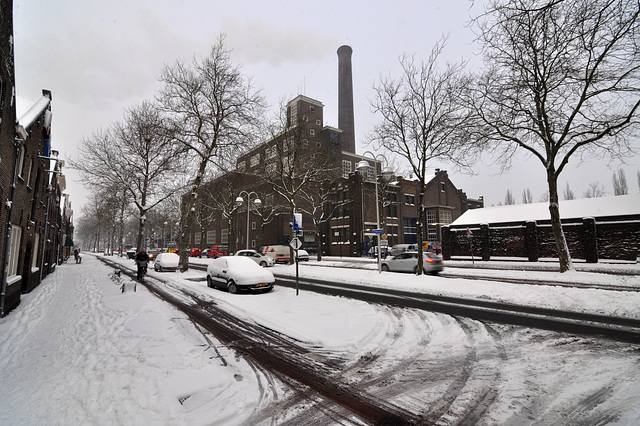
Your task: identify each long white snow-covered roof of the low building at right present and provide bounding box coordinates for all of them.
[451,194,640,226]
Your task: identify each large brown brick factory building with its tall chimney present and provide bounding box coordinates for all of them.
[191,46,484,256]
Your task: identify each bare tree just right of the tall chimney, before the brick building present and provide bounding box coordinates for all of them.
[371,37,473,275]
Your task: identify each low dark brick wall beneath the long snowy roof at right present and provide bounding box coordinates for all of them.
[442,217,640,263]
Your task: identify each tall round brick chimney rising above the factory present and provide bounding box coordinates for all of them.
[338,45,356,154]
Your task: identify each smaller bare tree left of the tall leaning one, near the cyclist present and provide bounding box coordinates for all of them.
[71,101,183,248]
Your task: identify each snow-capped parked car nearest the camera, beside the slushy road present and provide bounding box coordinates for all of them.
[207,256,275,293]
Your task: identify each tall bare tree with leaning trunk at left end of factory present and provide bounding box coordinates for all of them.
[158,35,264,271]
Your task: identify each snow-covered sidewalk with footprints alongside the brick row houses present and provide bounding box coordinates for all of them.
[0,255,270,425]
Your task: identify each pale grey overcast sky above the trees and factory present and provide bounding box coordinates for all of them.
[14,0,640,218]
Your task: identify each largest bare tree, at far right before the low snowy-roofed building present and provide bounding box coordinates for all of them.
[475,0,640,272]
